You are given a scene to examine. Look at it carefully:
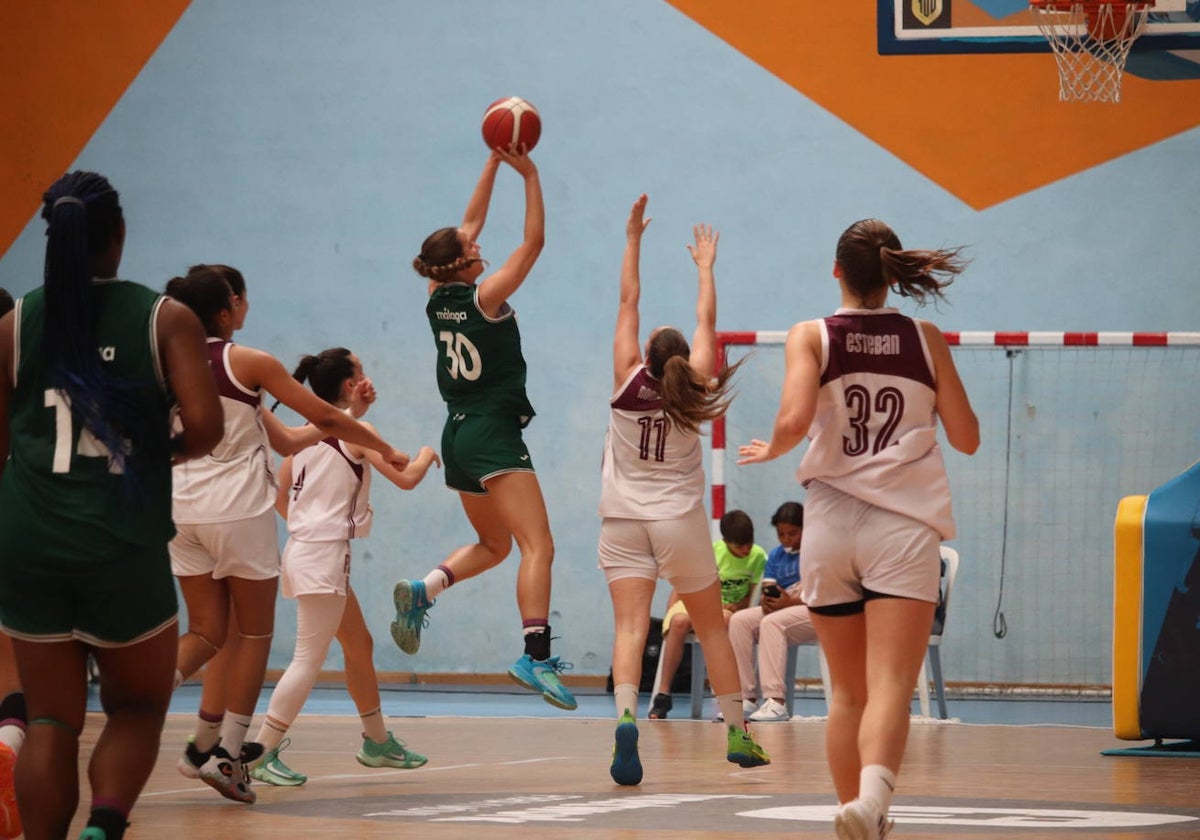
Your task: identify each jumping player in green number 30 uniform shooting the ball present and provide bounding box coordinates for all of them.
[391,149,576,709]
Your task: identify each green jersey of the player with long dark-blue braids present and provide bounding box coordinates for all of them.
[0,281,174,562]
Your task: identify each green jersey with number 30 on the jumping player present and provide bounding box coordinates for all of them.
[425,283,534,425]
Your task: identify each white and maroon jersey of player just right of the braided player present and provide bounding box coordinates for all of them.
[172,338,278,524]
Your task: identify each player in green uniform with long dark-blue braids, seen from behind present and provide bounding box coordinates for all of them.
[0,172,222,840]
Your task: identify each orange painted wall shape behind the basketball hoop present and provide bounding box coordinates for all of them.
[667,0,1200,210]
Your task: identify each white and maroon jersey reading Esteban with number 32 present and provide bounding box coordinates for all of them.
[797,308,954,540]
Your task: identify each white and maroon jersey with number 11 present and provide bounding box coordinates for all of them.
[600,365,704,520]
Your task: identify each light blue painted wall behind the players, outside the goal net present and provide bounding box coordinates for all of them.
[0,0,1200,682]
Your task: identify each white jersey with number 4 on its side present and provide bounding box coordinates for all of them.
[288,437,372,542]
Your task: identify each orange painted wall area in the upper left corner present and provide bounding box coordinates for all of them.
[0,0,191,254]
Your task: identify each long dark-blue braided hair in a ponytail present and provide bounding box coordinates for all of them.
[42,172,149,475]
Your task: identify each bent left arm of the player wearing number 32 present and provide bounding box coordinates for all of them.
[738,320,821,464]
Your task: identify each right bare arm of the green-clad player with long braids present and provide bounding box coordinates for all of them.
[155,298,224,461]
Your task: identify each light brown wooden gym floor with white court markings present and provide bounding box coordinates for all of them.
[63,707,1200,840]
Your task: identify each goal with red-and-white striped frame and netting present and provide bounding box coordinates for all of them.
[709,332,1200,695]
